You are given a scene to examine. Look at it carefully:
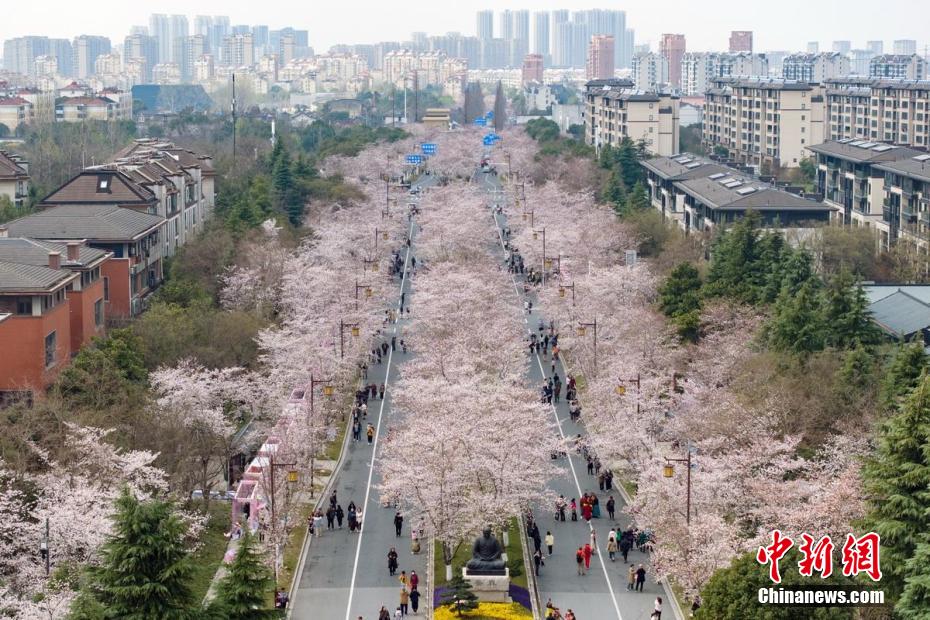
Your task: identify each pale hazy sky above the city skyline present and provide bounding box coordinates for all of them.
[0,0,930,52]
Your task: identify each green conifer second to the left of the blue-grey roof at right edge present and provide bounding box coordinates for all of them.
[762,281,826,356]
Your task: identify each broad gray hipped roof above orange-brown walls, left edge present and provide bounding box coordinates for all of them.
[7,205,165,241]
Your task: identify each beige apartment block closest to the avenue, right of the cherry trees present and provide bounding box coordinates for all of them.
[584,79,679,155]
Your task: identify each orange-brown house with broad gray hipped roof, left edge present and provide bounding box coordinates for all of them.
[7,204,165,320]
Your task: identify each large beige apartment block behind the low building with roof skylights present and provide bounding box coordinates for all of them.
[703,78,825,172]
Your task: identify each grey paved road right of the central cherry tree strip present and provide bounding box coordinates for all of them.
[477,174,674,620]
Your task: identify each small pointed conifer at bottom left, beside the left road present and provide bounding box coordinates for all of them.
[209,532,282,620]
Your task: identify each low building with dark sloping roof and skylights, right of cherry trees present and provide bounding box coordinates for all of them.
[641,154,833,233]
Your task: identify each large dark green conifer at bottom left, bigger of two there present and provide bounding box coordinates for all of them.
[72,489,202,620]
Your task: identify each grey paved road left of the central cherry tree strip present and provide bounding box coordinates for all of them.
[291,176,436,620]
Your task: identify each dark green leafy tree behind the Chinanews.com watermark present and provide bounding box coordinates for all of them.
[694,549,853,620]
